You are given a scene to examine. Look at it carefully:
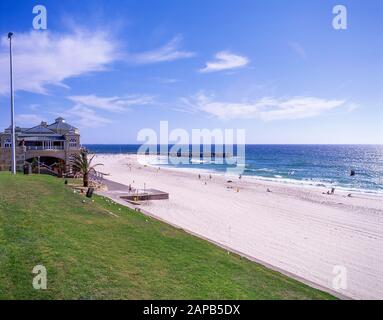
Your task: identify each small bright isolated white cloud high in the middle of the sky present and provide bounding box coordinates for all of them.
[200,51,250,72]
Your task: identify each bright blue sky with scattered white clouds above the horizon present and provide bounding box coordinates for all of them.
[0,0,383,143]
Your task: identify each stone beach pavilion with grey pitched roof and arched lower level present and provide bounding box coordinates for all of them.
[0,117,81,172]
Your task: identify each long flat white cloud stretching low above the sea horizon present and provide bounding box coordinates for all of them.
[182,93,346,121]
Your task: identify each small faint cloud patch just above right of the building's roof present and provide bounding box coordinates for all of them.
[64,105,112,128]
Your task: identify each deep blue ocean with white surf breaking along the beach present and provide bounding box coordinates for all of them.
[85,144,383,195]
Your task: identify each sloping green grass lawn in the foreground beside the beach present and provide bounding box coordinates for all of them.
[0,173,333,299]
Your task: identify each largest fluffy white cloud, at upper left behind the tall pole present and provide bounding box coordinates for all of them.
[0,30,118,94]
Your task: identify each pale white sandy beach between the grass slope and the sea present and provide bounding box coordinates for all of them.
[96,155,383,299]
